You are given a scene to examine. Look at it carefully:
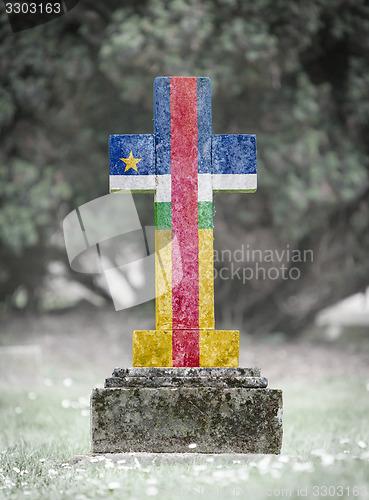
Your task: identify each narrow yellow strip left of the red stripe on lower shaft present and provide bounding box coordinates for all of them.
[155,229,172,330]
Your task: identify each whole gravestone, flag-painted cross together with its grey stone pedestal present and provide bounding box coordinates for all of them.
[91,77,282,453]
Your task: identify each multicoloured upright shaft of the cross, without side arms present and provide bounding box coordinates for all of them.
[155,78,214,366]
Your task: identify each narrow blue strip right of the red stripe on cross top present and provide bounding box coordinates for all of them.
[197,77,212,174]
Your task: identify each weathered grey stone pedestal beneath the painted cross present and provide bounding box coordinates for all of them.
[91,368,282,454]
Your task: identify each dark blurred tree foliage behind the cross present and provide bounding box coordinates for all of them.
[0,0,369,335]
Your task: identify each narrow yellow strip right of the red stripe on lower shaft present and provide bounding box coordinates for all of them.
[198,229,215,329]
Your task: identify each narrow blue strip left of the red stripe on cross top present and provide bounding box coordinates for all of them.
[154,76,171,175]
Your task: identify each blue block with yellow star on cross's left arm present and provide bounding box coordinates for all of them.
[109,134,155,176]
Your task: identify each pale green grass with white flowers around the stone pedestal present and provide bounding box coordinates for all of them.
[0,377,369,500]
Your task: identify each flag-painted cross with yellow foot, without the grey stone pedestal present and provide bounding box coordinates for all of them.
[110,77,256,366]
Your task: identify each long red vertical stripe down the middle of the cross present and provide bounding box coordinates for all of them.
[170,78,200,366]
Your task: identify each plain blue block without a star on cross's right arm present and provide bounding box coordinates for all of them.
[212,134,256,174]
